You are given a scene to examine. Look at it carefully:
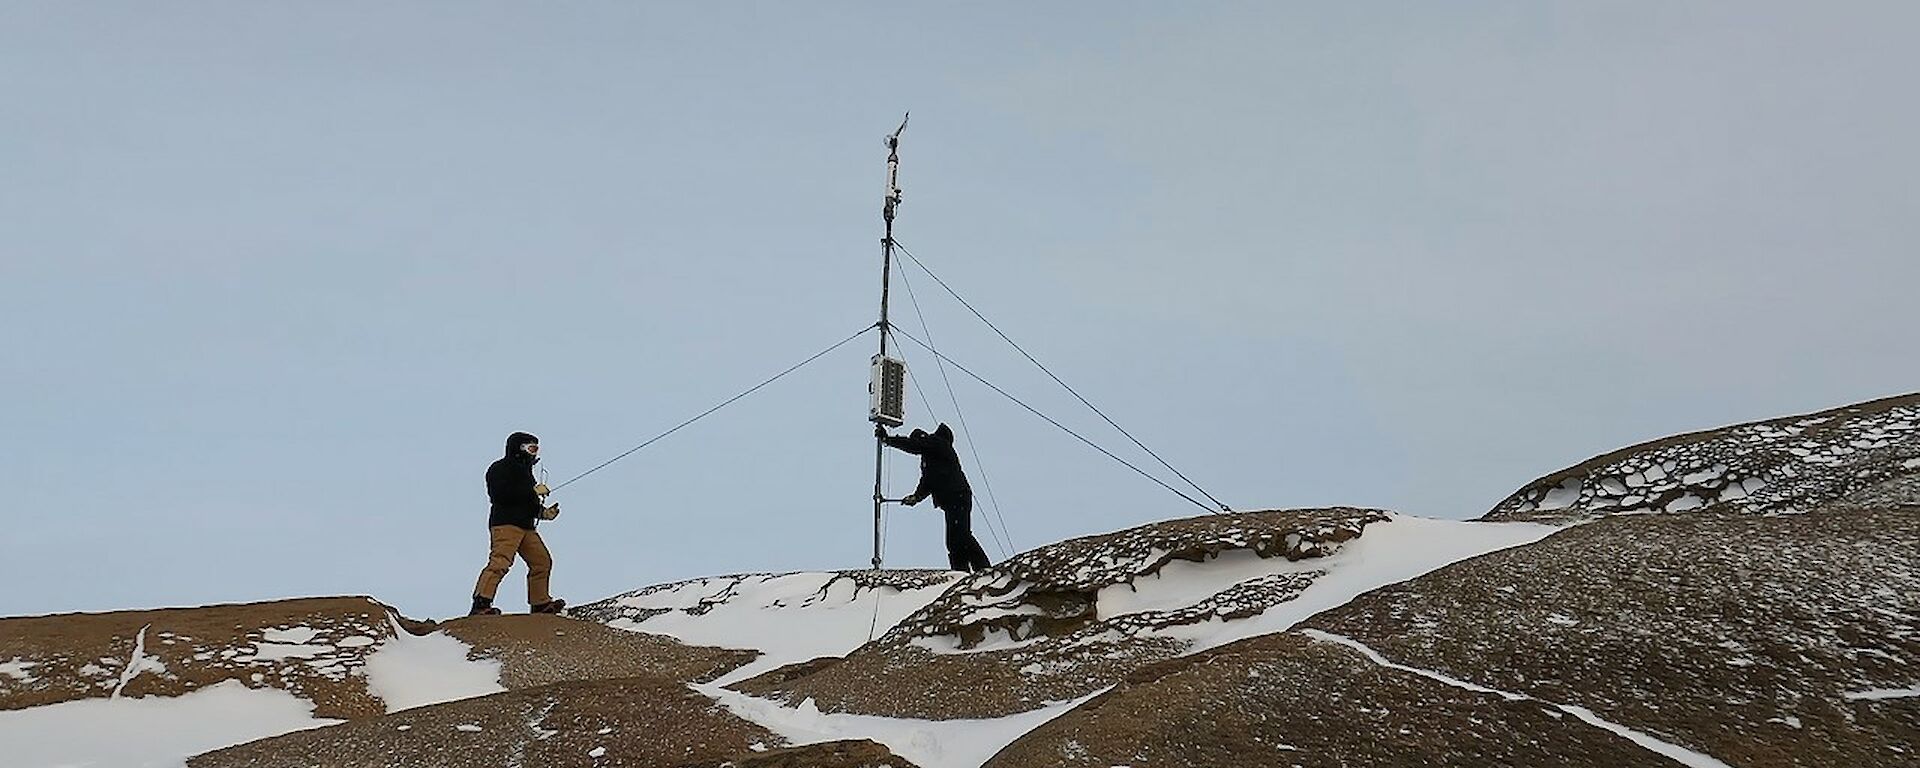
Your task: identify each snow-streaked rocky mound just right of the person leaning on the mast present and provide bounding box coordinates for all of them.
[732,509,1551,720]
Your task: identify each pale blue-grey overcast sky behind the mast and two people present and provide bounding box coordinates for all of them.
[0,0,1920,616]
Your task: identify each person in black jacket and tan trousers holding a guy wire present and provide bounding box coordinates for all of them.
[468,432,566,616]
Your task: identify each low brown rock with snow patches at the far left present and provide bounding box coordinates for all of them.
[0,597,778,766]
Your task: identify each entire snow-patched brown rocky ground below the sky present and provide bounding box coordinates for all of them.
[0,396,1920,768]
